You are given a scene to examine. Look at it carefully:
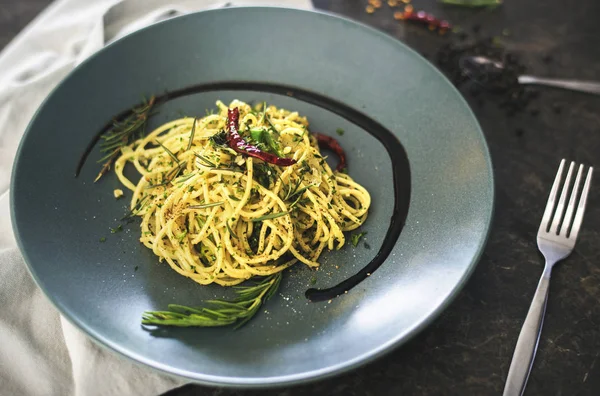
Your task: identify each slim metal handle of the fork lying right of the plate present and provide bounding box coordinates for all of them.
[502,263,552,396]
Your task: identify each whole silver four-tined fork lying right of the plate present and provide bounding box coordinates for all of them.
[503,159,594,396]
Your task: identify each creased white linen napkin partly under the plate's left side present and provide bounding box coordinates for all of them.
[0,0,312,396]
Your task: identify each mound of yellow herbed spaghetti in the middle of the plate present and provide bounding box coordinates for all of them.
[114,100,371,286]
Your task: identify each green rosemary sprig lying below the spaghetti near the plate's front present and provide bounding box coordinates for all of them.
[142,272,281,329]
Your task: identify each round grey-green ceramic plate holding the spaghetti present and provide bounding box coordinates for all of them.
[11,8,493,386]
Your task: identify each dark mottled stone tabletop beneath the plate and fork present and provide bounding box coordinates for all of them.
[0,0,600,396]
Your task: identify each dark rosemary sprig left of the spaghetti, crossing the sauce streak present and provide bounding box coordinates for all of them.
[94,96,156,183]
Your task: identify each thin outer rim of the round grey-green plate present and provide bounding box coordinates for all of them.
[10,6,496,389]
